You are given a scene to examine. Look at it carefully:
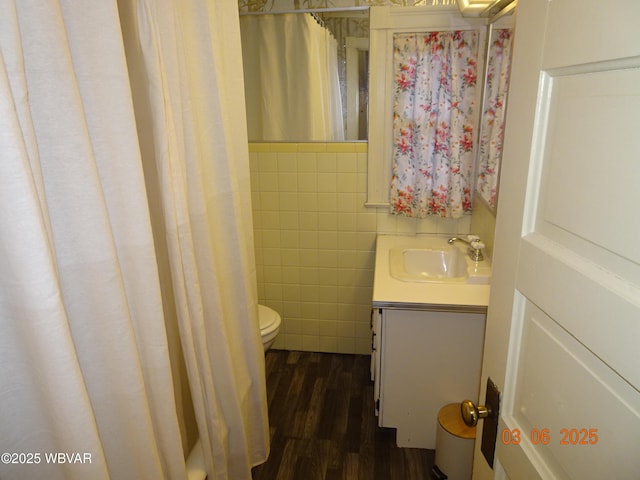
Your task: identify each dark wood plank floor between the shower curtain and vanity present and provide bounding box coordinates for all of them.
[253,350,434,480]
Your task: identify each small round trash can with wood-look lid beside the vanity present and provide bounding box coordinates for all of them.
[431,403,476,480]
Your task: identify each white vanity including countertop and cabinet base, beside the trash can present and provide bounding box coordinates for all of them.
[371,235,491,449]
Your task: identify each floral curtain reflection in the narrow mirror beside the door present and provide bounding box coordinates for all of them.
[477,28,513,207]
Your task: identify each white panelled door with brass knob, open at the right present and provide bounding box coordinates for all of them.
[474,0,640,480]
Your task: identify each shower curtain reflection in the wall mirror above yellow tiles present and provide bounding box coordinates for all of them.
[240,13,344,142]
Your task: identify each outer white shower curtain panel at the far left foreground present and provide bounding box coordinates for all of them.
[0,0,184,480]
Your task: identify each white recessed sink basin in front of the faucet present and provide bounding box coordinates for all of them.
[389,246,469,282]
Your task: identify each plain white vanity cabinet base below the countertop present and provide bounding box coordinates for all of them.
[371,305,486,449]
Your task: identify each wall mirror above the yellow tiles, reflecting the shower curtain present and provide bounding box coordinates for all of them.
[240,8,369,142]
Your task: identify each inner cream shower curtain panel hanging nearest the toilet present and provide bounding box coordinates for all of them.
[123,0,269,480]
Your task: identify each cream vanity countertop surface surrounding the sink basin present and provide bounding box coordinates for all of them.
[373,234,491,313]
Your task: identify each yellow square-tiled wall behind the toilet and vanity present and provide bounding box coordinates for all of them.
[249,142,471,354]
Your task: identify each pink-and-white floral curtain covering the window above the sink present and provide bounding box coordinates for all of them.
[390,30,480,218]
